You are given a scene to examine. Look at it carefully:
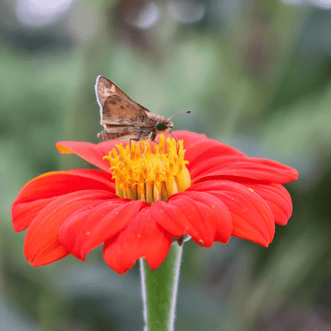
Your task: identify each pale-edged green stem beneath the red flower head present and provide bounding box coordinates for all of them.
[139,243,183,331]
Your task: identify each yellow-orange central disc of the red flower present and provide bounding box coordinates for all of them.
[104,135,191,203]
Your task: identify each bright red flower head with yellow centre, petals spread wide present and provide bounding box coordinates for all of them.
[12,131,298,274]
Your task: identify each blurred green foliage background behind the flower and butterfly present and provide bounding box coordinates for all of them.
[0,0,331,331]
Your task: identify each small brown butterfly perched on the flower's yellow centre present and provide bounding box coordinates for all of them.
[95,75,191,146]
